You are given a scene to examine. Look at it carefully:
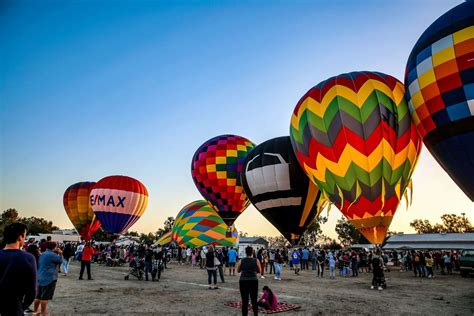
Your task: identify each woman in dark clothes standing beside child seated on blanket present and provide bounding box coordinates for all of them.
[237,246,262,316]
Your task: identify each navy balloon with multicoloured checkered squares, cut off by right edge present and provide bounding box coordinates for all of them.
[405,1,474,201]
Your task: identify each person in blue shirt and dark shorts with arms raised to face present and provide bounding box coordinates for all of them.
[34,241,63,315]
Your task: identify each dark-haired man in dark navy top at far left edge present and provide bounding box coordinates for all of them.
[0,223,37,315]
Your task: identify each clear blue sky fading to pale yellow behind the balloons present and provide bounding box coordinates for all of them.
[0,0,472,236]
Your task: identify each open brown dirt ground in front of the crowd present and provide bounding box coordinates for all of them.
[45,263,474,315]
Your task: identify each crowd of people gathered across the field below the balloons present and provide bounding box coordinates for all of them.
[0,223,466,315]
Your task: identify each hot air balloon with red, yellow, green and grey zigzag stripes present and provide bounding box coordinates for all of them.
[290,72,421,244]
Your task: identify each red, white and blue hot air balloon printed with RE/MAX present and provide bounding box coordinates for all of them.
[90,176,148,234]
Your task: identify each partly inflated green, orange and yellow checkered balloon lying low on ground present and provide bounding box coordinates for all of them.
[172,200,238,247]
